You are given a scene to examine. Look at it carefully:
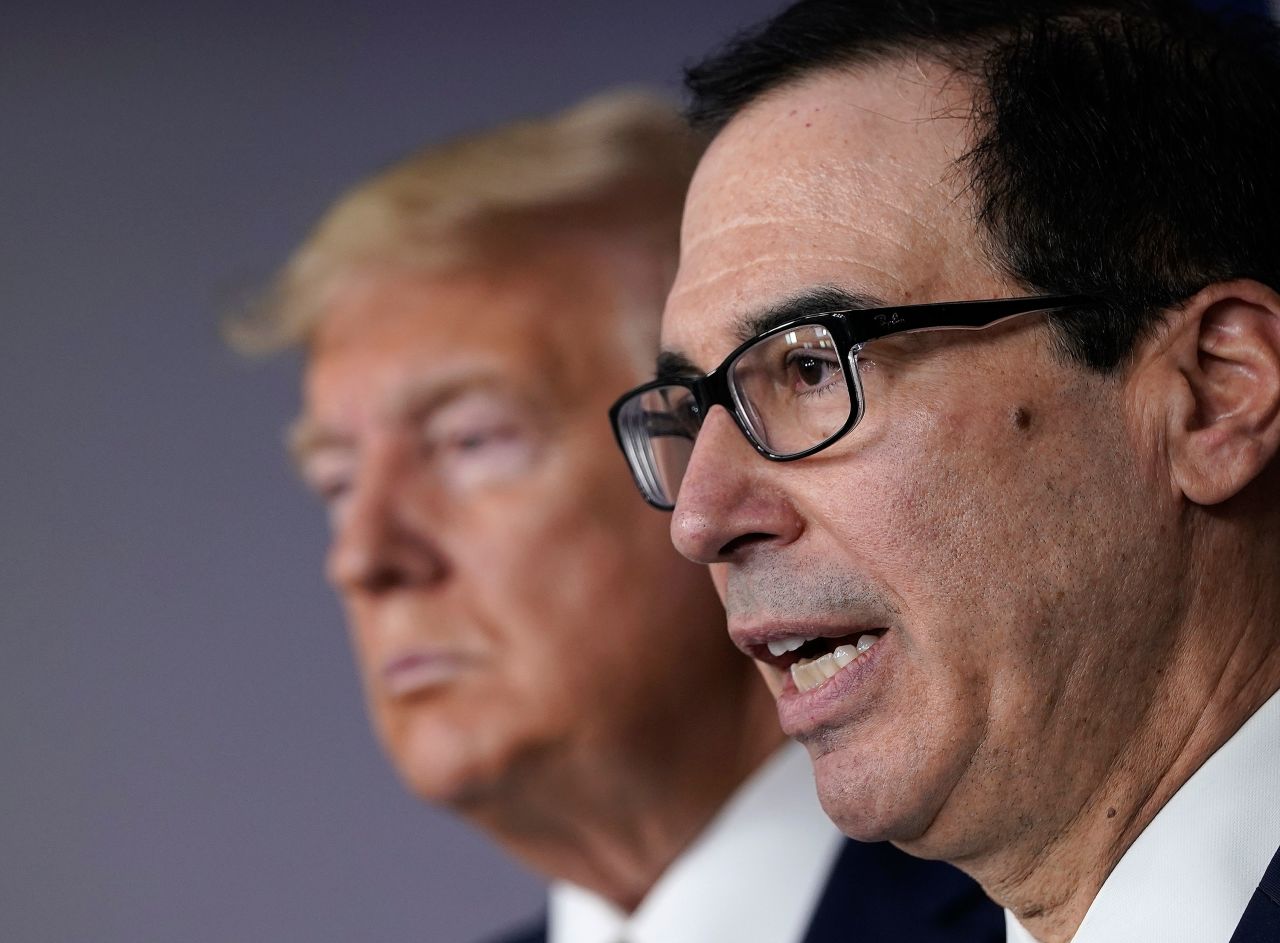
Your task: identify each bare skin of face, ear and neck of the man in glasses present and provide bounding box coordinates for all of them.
[662,61,1280,940]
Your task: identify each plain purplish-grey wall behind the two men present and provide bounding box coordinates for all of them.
[10,0,1280,943]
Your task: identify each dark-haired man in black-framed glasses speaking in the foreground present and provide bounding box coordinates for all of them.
[613,0,1280,943]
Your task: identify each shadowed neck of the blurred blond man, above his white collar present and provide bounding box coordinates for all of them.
[461,677,782,914]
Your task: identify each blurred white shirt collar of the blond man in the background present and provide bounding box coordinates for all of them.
[548,743,844,943]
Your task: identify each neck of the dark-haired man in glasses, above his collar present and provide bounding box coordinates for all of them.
[965,527,1280,943]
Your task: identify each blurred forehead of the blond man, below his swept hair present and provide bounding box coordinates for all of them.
[306,244,657,418]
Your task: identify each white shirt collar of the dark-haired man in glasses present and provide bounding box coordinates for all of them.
[1005,693,1280,943]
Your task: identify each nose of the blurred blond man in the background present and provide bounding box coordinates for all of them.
[326,456,448,592]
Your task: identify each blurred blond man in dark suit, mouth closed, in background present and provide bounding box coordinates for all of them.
[238,95,1001,943]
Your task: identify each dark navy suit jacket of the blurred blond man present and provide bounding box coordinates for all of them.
[481,841,998,943]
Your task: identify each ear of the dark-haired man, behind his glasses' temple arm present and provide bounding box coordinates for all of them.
[1158,279,1280,505]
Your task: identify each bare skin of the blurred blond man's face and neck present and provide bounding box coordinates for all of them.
[296,239,781,907]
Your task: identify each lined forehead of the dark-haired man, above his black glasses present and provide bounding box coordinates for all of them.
[663,60,1004,367]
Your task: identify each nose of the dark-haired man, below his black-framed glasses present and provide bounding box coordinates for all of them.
[671,406,803,563]
